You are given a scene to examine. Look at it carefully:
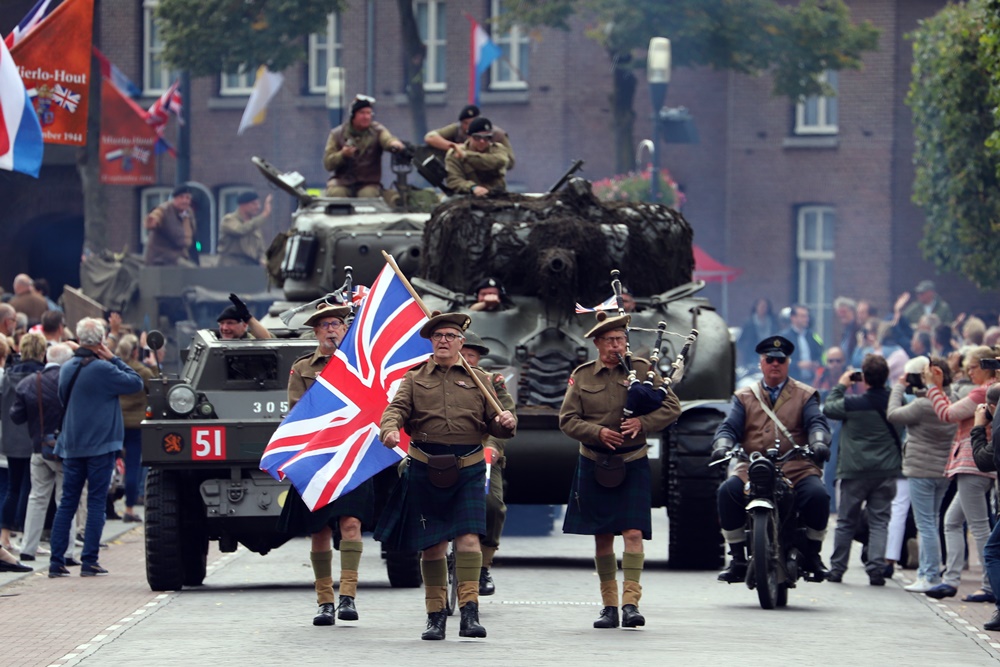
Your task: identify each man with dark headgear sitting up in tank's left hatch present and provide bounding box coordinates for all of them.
[323,95,404,197]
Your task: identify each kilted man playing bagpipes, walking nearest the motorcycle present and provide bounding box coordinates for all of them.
[559,315,681,628]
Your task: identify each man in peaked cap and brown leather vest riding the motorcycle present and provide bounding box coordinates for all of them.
[712,336,830,583]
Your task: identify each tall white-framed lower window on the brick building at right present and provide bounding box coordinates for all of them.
[795,206,836,340]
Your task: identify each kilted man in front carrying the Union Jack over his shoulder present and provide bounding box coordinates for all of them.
[375,313,517,640]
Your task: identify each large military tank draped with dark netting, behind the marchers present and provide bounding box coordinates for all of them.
[255,158,735,569]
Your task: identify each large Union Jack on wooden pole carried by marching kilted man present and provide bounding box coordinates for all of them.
[260,266,431,511]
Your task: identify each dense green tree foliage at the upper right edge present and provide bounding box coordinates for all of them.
[906,0,1000,289]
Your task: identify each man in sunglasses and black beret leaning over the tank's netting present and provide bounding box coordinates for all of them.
[444,116,513,197]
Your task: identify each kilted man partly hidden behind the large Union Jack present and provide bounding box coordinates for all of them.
[280,302,375,625]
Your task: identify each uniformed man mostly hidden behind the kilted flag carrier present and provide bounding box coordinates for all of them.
[462,331,515,595]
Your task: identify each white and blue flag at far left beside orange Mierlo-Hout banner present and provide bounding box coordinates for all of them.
[0,36,45,178]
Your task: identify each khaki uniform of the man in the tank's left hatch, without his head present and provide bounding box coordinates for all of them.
[323,120,398,197]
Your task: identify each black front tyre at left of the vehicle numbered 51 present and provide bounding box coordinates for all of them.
[145,468,184,591]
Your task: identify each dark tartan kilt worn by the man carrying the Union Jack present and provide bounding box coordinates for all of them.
[375,459,486,551]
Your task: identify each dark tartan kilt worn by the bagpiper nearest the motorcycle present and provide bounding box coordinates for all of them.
[563,456,653,540]
